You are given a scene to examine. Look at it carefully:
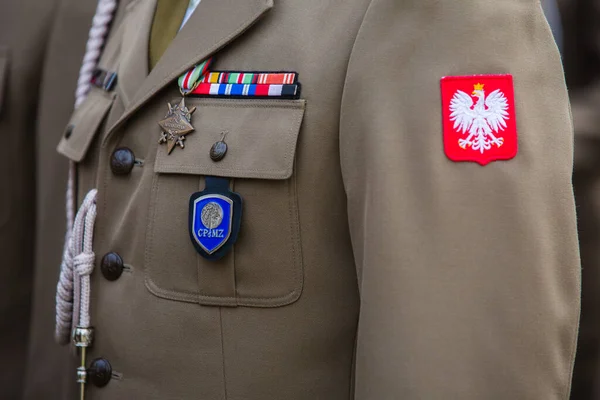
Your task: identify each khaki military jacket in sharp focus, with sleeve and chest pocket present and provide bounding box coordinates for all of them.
[58,0,579,400]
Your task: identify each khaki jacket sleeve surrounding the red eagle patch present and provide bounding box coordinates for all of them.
[340,0,580,400]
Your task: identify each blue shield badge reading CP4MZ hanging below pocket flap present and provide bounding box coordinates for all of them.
[189,176,242,260]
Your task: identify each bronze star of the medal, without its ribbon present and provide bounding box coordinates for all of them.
[158,98,196,154]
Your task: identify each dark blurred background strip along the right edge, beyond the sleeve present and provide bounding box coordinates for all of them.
[560,0,600,400]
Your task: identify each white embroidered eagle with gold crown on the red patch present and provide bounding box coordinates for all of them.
[450,83,508,154]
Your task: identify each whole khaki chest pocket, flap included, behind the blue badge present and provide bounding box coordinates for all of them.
[145,99,305,307]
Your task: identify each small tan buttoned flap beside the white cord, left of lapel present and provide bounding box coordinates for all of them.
[57,88,115,162]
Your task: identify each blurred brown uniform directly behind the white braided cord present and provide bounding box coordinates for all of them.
[21,0,103,400]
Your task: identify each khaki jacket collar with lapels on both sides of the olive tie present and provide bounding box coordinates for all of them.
[104,0,273,142]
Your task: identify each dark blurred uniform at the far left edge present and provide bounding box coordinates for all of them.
[0,0,55,399]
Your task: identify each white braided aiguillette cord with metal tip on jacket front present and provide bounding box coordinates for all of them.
[54,0,117,399]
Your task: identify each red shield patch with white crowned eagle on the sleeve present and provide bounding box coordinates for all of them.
[441,75,518,165]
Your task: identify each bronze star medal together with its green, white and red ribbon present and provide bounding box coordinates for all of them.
[158,58,212,154]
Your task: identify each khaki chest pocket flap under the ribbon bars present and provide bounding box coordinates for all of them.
[154,98,305,179]
